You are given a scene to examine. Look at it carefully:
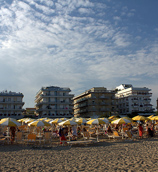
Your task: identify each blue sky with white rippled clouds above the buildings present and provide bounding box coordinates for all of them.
[0,0,158,107]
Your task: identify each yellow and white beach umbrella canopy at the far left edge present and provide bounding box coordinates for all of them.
[0,118,21,127]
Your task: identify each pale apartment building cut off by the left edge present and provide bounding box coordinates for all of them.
[0,90,24,119]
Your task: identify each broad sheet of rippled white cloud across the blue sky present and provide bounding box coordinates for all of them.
[0,0,158,106]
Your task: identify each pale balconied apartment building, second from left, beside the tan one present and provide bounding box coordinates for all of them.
[35,86,74,118]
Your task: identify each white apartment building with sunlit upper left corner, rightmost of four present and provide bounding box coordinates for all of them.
[115,84,153,114]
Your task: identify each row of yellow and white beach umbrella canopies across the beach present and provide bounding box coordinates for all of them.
[0,116,158,126]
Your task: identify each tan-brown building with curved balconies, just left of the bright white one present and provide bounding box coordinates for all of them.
[73,87,116,118]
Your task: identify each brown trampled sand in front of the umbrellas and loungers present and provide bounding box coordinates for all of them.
[0,138,158,172]
